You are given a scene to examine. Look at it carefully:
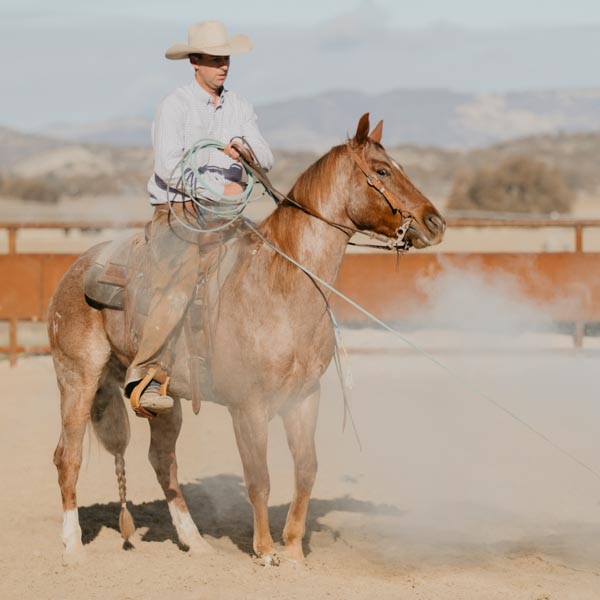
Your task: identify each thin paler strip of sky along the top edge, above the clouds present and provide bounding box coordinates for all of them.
[7,0,600,27]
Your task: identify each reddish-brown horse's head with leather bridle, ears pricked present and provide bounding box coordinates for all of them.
[346,113,446,248]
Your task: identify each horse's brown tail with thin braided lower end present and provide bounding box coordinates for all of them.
[91,357,135,541]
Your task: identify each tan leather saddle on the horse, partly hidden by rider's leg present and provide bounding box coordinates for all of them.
[84,232,239,414]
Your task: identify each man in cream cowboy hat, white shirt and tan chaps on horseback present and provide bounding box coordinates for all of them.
[125,21,273,416]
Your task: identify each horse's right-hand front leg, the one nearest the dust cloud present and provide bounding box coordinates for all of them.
[282,388,320,561]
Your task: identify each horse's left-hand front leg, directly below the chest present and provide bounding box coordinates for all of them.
[230,405,279,565]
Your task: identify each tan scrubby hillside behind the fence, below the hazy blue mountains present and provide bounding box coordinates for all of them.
[0,129,600,207]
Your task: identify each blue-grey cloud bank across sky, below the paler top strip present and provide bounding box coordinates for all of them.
[0,12,600,130]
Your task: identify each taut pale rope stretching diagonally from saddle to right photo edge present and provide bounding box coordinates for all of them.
[244,219,600,480]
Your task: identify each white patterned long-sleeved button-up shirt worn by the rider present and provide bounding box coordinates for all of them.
[148,79,273,204]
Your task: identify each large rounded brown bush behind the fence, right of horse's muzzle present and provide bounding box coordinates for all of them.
[448,156,574,214]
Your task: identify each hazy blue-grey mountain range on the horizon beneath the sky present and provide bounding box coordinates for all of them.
[34,88,600,152]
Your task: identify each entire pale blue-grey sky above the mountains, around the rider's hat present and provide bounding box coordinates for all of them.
[0,0,600,131]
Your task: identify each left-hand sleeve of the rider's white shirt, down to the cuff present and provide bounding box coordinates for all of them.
[152,96,225,200]
